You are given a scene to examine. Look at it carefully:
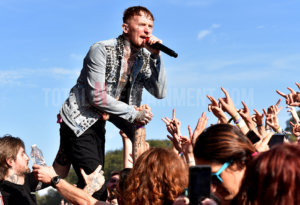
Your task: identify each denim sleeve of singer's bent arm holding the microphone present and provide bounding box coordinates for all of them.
[144,55,167,99]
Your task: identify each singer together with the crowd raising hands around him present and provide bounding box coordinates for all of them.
[0,3,300,205]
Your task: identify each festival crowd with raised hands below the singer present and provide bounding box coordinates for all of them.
[0,84,300,205]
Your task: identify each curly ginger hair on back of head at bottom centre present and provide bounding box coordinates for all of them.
[122,148,188,205]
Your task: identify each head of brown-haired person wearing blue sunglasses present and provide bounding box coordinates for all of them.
[194,124,256,204]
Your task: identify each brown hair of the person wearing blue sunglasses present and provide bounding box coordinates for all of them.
[194,124,256,169]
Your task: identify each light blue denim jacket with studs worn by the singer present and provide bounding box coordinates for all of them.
[60,35,167,136]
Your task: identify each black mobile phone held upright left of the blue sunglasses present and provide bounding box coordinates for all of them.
[188,165,211,205]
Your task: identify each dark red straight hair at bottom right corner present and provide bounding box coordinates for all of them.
[235,143,300,205]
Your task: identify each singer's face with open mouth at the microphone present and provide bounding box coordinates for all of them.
[123,12,153,48]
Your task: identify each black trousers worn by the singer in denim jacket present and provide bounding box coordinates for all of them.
[60,115,135,201]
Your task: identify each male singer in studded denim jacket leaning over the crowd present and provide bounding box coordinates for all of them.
[55,6,166,199]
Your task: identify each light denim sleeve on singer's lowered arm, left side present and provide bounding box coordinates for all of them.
[84,44,138,122]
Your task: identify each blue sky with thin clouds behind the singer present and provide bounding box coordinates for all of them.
[0,0,300,165]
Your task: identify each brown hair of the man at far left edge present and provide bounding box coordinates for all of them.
[0,135,25,180]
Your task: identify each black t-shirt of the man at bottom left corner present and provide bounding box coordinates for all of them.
[0,173,38,205]
